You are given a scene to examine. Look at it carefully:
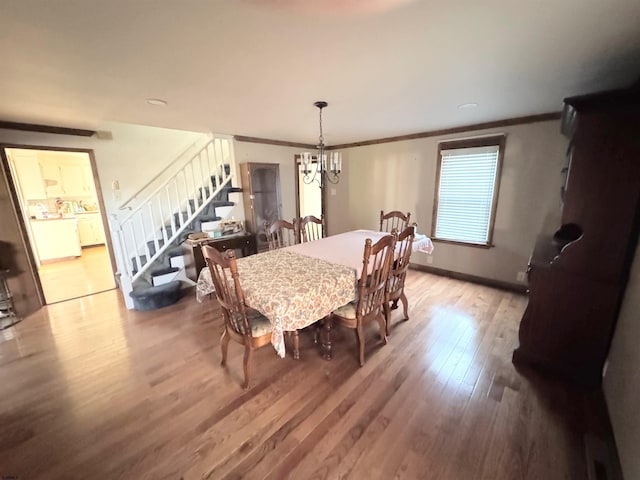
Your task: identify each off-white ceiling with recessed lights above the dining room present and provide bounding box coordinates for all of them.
[0,0,640,145]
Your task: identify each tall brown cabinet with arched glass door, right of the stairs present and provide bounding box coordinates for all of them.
[240,163,282,252]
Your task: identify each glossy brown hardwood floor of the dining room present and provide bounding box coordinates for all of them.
[0,271,600,480]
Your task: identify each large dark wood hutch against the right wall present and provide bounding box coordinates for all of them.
[513,86,640,385]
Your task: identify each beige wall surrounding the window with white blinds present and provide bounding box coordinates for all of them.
[338,121,567,283]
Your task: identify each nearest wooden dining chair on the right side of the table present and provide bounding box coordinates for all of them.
[325,233,396,367]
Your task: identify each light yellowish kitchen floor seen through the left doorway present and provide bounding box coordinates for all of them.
[38,245,116,304]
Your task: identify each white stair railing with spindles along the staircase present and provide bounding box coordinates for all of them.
[111,136,234,290]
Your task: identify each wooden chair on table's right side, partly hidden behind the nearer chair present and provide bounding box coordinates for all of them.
[384,224,416,335]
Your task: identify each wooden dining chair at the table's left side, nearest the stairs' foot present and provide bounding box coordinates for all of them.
[202,245,272,388]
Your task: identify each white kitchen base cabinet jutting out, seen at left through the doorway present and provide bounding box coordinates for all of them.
[31,218,82,262]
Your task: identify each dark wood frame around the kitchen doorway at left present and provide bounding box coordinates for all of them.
[0,143,119,305]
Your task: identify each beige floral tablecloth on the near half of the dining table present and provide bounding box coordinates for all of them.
[196,249,362,357]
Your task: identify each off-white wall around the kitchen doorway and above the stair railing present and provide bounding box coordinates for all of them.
[0,123,204,315]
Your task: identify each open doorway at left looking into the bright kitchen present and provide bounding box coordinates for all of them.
[3,146,116,304]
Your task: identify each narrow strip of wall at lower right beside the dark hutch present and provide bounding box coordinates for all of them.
[603,242,640,479]
